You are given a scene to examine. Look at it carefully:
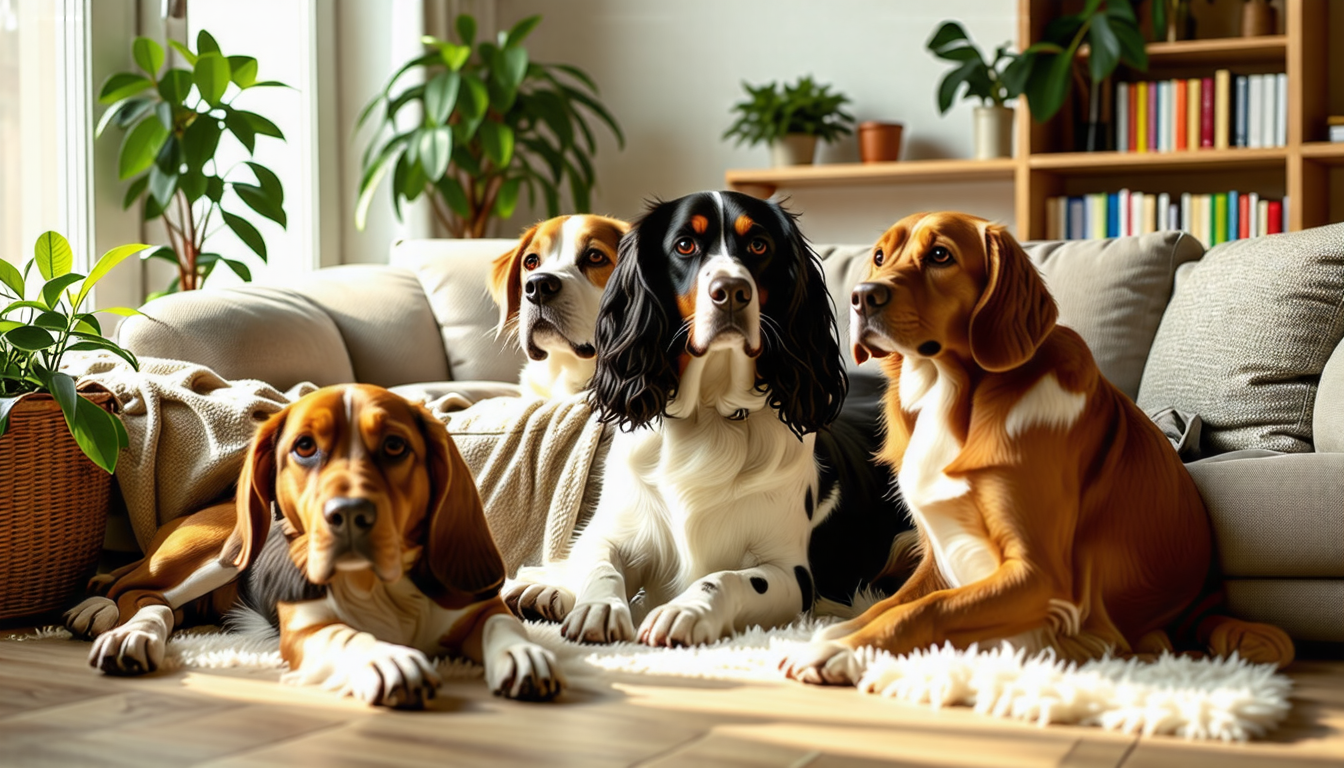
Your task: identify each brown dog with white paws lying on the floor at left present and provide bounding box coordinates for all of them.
[66,385,564,709]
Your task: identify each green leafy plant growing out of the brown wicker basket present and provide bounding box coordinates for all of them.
[0,231,151,473]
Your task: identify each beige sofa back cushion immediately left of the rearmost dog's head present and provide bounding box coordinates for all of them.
[391,239,527,382]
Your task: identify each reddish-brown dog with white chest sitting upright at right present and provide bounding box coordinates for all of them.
[781,213,1293,683]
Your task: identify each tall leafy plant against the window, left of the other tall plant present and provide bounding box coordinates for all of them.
[94,31,288,299]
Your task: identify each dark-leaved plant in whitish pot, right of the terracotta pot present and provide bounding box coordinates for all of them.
[926,22,1031,160]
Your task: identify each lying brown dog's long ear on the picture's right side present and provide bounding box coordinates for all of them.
[411,408,505,609]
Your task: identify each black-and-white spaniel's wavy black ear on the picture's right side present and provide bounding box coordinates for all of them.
[757,208,849,437]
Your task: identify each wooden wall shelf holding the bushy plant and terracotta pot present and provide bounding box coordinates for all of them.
[726,159,1017,196]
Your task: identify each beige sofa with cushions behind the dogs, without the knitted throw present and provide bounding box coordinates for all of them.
[120,225,1344,642]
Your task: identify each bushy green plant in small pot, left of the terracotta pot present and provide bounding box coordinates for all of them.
[723,75,853,165]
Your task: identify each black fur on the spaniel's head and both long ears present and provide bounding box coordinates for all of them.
[591,192,848,437]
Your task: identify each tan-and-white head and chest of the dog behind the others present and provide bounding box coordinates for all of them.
[491,214,630,398]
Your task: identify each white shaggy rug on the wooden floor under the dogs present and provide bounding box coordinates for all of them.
[8,619,1293,741]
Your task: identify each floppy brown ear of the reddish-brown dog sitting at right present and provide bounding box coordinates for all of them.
[970,225,1059,371]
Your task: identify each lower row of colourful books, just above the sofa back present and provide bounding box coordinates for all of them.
[1046,190,1288,246]
